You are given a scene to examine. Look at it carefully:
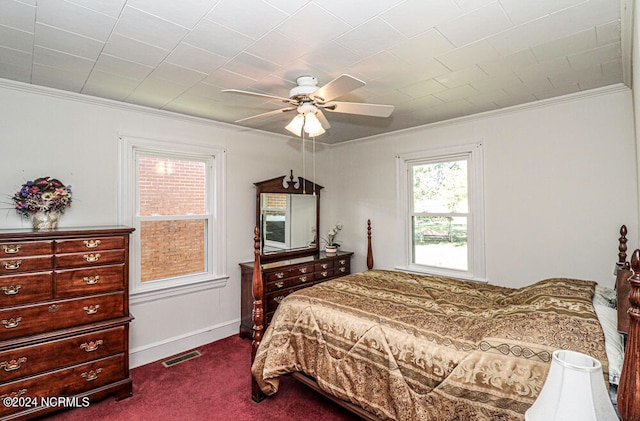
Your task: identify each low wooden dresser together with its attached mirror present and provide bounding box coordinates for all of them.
[240,171,353,338]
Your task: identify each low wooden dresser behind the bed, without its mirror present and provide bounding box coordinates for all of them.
[240,251,353,338]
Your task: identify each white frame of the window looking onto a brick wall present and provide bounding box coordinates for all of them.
[118,136,228,303]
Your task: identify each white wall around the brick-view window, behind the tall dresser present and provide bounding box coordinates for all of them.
[0,80,320,366]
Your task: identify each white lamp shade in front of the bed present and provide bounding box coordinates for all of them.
[524,350,618,421]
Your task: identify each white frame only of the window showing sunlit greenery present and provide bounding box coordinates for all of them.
[396,143,486,282]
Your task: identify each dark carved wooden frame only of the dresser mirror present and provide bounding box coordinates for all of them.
[254,170,323,262]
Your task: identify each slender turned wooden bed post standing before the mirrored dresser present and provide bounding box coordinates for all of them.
[251,226,265,402]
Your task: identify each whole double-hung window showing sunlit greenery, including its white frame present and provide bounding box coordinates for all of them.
[398,144,485,280]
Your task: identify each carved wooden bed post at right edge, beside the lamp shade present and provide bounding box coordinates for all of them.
[618,249,640,421]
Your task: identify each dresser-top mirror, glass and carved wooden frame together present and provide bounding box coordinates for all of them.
[255,171,322,259]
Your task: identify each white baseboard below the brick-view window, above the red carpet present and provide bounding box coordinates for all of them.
[129,320,240,368]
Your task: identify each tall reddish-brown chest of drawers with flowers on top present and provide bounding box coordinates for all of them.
[0,226,133,420]
